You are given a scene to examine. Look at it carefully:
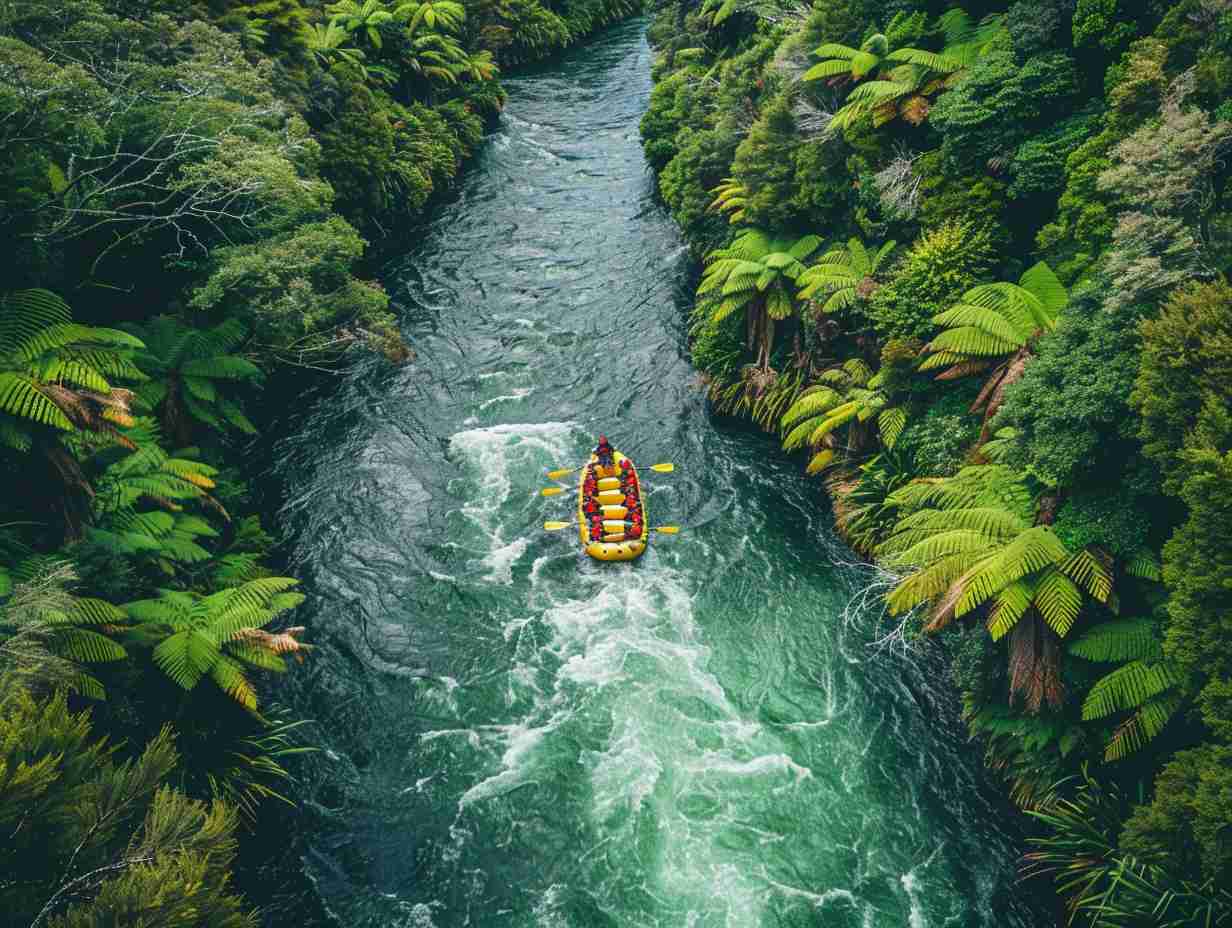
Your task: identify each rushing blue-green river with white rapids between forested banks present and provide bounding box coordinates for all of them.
[277,22,1042,928]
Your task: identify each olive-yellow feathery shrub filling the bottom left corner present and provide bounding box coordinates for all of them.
[0,690,256,928]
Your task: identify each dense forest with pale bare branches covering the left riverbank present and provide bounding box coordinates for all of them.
[0,0,636,928]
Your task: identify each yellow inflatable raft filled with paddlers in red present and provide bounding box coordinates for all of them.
[578,451,647,561]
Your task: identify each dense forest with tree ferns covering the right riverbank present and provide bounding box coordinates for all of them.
[642,0,1232,926]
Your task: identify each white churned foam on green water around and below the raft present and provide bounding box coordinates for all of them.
[432,423,832,928]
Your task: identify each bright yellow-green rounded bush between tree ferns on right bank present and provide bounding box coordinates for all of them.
[864,223,991,338]
